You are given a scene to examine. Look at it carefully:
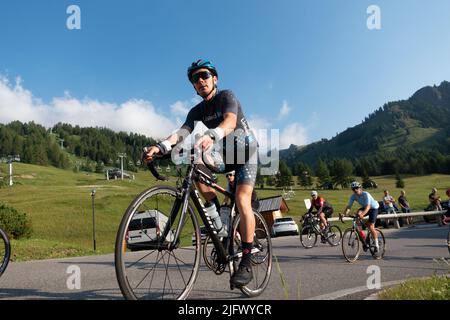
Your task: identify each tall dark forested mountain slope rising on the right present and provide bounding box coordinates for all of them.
[281,81,450,175]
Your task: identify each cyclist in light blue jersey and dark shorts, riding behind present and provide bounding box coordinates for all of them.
[344,181,380,252]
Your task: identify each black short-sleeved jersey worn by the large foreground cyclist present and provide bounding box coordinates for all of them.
[182,90,250,135]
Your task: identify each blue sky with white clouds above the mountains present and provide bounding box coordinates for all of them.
[0,0,450,146]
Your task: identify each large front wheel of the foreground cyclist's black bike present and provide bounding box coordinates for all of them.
[115,186,201,300]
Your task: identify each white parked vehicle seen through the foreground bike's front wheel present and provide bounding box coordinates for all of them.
[126,210,174,251]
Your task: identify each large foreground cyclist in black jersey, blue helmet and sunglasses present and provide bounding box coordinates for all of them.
[144,60,258,287]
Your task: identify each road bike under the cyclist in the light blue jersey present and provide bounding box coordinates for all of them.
[339,215,386,262]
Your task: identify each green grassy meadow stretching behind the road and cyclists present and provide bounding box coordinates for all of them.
[0,163,450,261]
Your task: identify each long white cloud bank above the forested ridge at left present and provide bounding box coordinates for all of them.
[0,77,178,139]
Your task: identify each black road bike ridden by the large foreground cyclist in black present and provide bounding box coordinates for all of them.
[115,152,272,300]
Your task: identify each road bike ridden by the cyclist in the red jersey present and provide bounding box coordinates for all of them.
[300,212,342,249]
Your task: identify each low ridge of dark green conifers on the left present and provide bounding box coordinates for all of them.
[0,121,154,171]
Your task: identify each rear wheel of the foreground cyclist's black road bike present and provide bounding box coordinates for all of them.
[231,211,273,297]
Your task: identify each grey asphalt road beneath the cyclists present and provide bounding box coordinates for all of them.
[0,224,450,300]
